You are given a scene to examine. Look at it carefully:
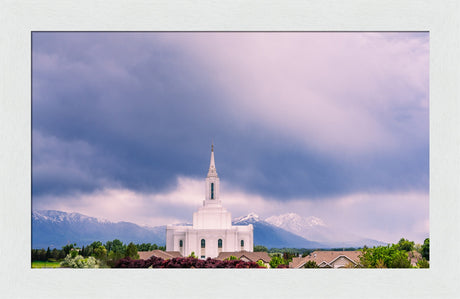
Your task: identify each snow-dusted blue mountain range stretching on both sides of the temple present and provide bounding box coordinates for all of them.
[32,210,384,248]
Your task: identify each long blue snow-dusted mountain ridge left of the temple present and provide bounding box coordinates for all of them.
[32,210,166,248]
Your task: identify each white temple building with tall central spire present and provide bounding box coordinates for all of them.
[166,146,254,259]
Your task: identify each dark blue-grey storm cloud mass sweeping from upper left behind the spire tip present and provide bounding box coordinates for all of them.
[32,33,429,199]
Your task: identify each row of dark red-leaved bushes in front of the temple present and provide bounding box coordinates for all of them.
[114,256,263,268]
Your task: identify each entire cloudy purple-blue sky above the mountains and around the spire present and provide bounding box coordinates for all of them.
[32,32,429,243]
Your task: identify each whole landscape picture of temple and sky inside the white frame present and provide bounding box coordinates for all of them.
[31,32,430,271]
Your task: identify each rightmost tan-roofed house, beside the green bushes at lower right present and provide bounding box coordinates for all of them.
[289,251,361,268]
